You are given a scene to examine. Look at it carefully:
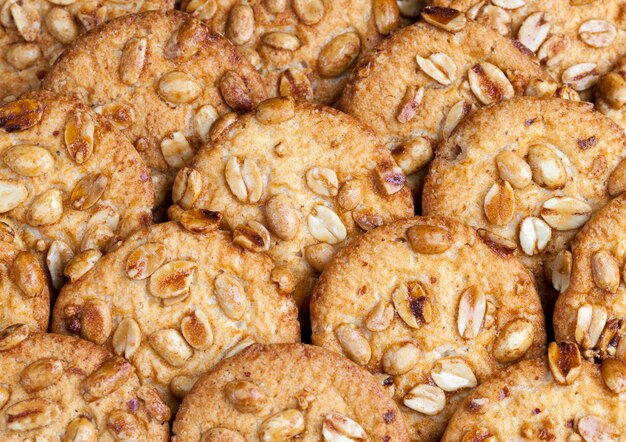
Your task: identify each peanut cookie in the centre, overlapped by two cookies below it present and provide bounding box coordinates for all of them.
[178,97,413,307]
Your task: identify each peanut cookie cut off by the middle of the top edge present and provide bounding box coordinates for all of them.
[182,0,400,104]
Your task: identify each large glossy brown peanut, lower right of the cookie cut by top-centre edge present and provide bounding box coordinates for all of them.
[317,32,361,78]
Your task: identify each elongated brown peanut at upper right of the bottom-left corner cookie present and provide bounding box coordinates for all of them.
[80,356,135,402]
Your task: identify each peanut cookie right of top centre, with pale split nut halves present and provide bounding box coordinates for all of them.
[339,17,556,200]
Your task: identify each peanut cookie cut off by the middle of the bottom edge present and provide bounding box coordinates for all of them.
[172,344,409,442]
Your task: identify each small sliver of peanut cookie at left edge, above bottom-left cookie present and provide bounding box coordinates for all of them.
[0,242,50,332]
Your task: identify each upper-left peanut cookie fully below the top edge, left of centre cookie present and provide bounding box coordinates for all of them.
[42,11,265,206]
